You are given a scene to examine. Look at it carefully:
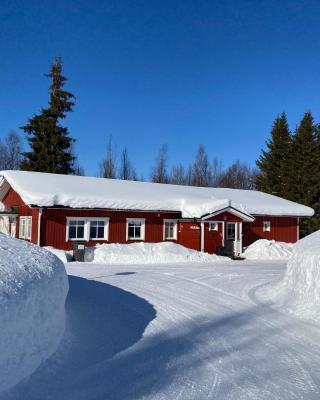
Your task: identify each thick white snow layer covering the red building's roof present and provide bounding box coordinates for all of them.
[0,171,314,218]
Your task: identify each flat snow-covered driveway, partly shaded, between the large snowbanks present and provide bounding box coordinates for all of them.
[0,261,320,400]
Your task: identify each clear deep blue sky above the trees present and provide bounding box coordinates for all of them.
[0,0,320,177]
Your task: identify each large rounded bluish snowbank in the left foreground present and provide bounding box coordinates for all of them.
[0,234,68,392]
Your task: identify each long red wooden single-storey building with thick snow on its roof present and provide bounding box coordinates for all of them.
[0,171,314,255]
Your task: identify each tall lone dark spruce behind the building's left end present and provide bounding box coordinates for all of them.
[21,57,75,174]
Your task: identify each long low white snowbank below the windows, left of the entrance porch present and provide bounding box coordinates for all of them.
[86,242,230,265]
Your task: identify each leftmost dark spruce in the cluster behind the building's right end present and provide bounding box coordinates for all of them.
[255,113,292,198]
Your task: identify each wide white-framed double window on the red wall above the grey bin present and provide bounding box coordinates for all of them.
[66,217,109,241]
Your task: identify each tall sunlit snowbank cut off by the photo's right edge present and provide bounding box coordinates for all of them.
[268,231,320,322]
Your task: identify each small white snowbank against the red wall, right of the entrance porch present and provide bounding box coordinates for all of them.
[243,239,294,260]
